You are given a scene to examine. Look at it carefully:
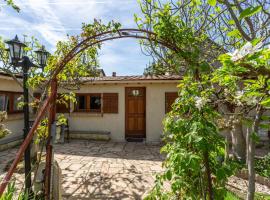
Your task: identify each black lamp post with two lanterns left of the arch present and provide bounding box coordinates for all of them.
[6,35,49,192]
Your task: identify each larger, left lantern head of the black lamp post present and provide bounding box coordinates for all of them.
[6,35,26,66]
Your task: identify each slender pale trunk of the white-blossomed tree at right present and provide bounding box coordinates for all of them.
[247,105,263,200]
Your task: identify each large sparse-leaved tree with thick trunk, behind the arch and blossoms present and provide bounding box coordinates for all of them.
[138,0,270,160]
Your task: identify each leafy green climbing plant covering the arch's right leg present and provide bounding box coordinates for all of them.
[148,76,237,199]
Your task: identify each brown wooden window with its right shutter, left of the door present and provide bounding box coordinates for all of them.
[76,93,118,113]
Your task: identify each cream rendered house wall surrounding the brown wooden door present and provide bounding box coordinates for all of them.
[66,82,177,142]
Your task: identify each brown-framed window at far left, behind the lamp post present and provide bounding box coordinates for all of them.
[0,91,23,113]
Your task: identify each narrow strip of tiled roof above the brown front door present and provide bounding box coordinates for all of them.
[83,75,182,82]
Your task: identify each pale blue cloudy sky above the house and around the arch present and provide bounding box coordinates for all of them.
[0,0,151,75]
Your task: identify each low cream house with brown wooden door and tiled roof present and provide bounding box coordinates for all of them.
[0,72,180,145]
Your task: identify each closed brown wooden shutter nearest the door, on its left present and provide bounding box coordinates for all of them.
[103,93,118,113]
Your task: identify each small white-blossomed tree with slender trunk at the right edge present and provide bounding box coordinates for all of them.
[214,43,270,200]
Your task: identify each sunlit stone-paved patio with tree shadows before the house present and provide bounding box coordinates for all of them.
[0,140,165,200]
